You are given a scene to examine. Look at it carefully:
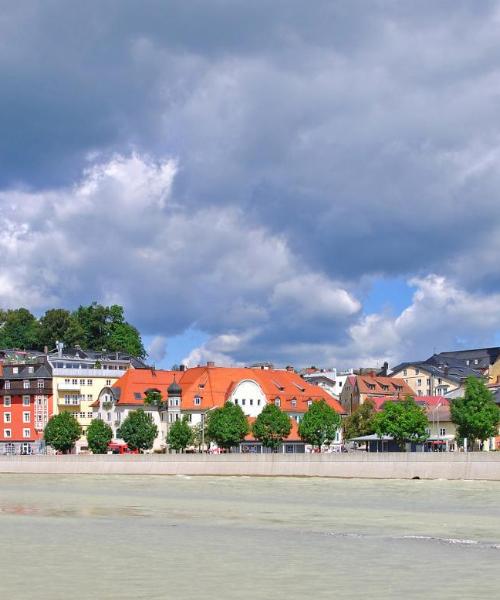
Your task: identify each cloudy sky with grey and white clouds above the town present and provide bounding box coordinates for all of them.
[0,0,500,367]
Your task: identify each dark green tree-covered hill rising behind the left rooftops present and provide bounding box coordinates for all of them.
[0,302,146,358]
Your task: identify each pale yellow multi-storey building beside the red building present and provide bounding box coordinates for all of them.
[47,343,146,452]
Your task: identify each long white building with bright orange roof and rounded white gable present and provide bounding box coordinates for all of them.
[92,363,342,449]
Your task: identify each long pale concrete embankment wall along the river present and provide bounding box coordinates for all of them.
[0,452,500,481]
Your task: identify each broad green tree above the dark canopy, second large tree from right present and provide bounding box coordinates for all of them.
[373,396,429,450]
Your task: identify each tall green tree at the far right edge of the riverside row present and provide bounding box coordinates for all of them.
[451,377,500,444]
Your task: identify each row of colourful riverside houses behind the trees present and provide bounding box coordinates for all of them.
[0,344,500,454]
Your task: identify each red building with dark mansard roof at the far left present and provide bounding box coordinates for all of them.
[0,352,53,454]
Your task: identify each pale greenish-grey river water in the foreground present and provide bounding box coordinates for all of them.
[0,475,500,600]
